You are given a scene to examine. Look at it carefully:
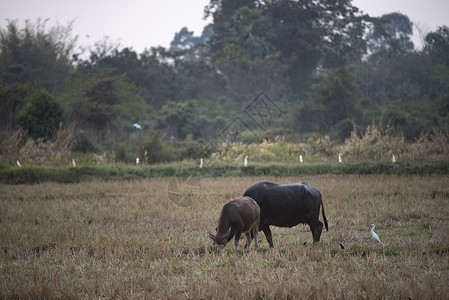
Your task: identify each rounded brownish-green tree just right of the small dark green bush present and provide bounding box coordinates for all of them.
[61,70,150,141]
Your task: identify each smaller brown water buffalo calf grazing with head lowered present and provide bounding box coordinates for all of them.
[209,197,260,248]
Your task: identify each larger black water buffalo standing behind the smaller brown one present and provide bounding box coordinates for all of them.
[243,182,329,247]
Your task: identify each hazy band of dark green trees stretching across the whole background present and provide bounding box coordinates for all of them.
[0,0,449,162]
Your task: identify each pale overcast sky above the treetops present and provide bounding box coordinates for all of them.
[0,0,449,53]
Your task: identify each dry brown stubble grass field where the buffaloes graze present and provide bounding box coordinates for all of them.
[0,175,449,299]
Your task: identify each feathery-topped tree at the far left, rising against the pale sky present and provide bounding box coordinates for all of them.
[0,20,77,94]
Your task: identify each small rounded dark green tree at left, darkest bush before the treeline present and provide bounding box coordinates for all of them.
[17,89,63,139]
